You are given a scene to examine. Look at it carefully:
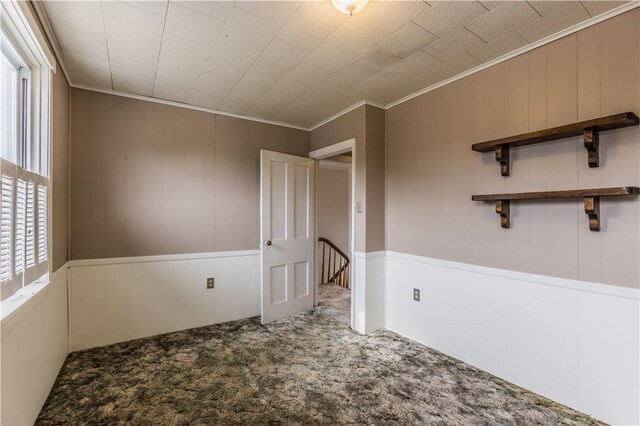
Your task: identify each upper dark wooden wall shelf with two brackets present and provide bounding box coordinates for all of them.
[471,112,639,176]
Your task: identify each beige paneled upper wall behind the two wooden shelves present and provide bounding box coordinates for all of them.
[386,9,640,288]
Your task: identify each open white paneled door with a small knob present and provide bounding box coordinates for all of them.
[260,150,315,324]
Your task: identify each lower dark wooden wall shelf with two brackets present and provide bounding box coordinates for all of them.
[471,186,640,231]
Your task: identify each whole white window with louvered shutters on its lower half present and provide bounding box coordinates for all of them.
[0,1,50,300]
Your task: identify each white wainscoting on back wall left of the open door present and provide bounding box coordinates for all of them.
[69,250,260,352]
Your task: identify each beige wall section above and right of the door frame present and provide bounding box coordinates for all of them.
[311,105,385,252]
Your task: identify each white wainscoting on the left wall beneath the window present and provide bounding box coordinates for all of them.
[0,265,69,425]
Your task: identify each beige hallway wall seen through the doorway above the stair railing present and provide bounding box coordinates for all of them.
[316,165,351,253]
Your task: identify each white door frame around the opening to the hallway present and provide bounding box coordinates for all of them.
[309,138,358,328]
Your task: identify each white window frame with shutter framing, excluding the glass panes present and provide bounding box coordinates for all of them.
[0,0,55,301]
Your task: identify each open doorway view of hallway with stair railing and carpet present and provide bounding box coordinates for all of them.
[316,151,353,325]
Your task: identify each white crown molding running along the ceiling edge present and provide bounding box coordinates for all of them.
[36,0,640,131]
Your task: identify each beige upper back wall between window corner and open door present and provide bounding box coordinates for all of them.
[70,89,309,259]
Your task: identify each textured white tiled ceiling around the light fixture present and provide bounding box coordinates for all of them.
[44,0,625,127]
